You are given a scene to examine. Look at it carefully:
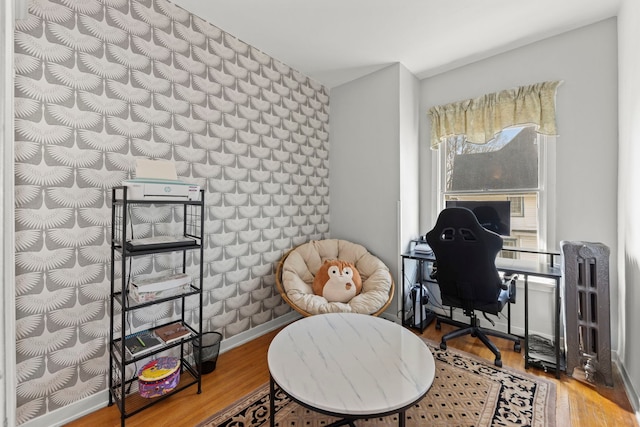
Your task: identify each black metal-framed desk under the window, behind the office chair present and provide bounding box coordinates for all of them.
[401,247,564,378]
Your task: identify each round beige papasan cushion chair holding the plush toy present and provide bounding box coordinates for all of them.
[276,239,394,316]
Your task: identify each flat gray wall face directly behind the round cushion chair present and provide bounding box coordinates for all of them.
[329,65,400,267]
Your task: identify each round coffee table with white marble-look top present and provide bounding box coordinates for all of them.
[267,313,435,426]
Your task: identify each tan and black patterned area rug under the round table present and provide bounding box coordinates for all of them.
[198,340,556,427]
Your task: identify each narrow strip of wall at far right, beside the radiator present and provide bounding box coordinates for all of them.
[617,0,640,415]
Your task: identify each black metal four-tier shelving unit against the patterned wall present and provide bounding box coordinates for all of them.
[109,187,204,426]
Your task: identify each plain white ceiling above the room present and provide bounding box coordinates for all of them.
[173,0,620,88]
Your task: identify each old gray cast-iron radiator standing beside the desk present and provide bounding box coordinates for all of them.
[560,241,613,386]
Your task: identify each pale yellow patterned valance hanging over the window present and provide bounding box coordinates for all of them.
[428,81,562,149]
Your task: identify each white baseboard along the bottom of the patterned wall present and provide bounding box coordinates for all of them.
[20,311,301,427]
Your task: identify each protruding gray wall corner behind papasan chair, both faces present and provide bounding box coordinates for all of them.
[330,64,419,316]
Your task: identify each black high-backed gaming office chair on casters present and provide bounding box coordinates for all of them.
[427,207,521,366]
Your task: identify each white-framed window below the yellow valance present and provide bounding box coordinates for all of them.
[439,126,549,258]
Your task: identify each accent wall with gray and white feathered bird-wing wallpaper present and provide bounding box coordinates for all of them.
[15,0,329,423]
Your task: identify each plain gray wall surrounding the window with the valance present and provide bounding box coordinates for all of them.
[420,19,619,349]
